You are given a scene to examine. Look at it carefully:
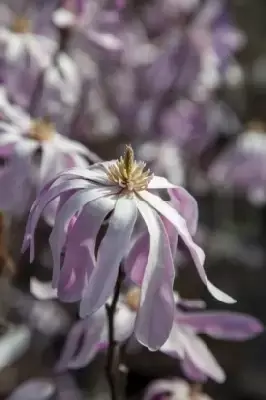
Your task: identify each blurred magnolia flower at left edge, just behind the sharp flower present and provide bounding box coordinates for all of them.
[0,96,98,223]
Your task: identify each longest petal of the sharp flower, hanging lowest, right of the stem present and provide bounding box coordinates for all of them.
[135,200,175,350]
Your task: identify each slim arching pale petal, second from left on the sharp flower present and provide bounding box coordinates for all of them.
[49,187,116,287]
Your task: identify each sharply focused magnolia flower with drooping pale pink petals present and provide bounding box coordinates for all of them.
[23,146,234,349]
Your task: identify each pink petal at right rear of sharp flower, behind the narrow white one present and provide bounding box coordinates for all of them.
[168,187,199,236]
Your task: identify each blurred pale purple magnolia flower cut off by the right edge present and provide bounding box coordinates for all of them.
[208,122,266,205]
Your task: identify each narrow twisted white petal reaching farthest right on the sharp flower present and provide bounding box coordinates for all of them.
[139,191,235,304]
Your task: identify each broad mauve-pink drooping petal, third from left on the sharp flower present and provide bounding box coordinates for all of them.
[58,198,115,301]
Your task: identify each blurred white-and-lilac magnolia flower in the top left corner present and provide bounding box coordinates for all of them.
[0,2,57,107]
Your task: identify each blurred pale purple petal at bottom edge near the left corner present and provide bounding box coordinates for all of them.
[7,378,56,400]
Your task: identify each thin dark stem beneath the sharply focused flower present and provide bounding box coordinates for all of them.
[106,268,123,400]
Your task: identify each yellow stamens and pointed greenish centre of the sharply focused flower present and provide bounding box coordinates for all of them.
[107,146,153,192]
